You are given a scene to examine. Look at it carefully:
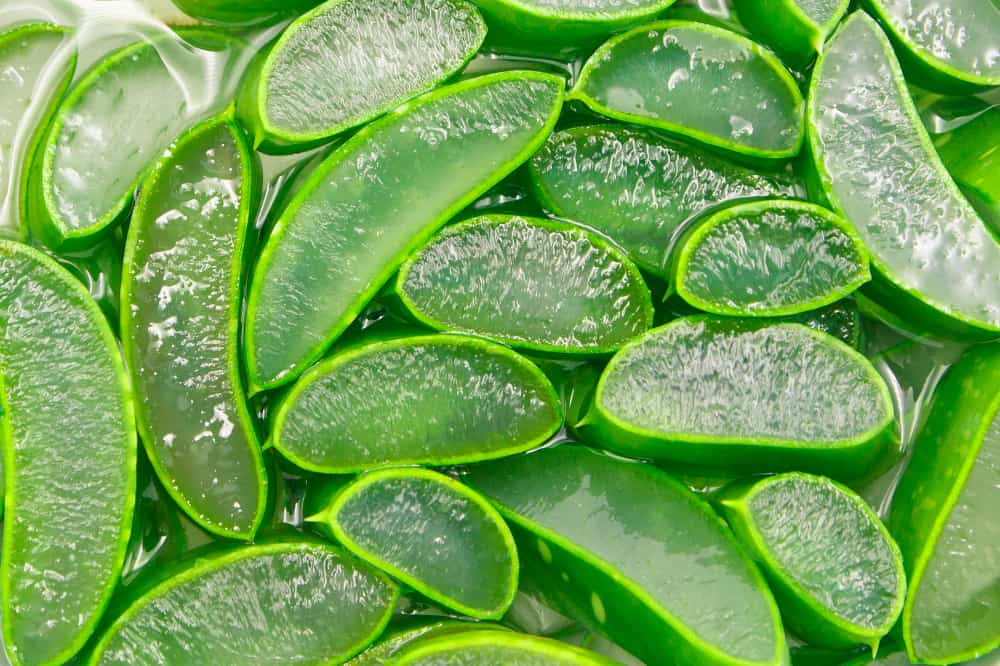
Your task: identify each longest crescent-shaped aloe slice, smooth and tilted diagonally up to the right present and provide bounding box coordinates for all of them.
[246,71,564,389]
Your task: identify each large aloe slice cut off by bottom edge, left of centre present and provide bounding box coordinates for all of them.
[88,542,399,666]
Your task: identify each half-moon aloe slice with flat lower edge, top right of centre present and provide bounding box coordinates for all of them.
[569,21,803,159]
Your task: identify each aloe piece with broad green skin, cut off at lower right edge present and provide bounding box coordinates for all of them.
[889,345,1000,664]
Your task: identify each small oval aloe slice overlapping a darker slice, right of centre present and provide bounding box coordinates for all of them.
[672,201,871,317]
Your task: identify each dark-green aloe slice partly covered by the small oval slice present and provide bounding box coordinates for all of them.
[530,125,794,278]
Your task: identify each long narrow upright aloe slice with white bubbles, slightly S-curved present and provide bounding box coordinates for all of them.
[121,120,267,539]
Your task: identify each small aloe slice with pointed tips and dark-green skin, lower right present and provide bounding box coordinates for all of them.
[719,472,906,654]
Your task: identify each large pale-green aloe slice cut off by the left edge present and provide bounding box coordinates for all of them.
[0,241,136,666]
